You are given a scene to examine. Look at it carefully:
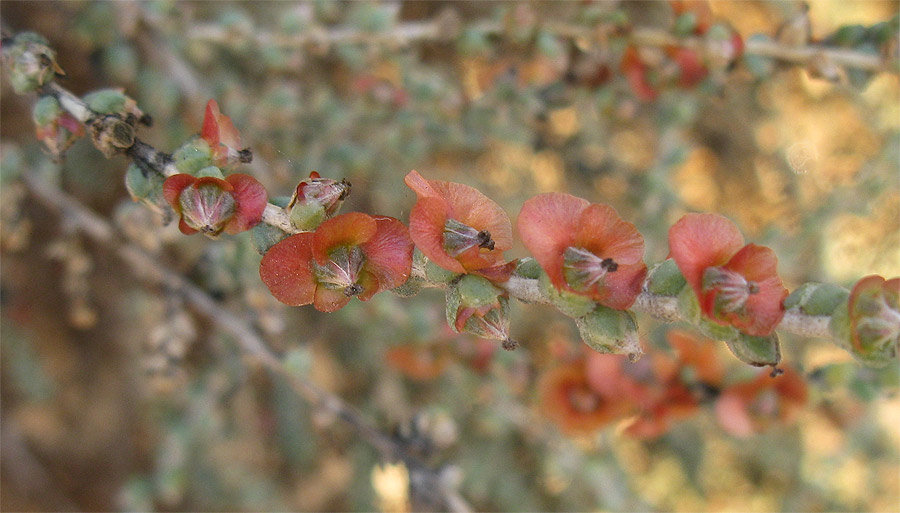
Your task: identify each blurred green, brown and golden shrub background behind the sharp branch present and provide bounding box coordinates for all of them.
[0,0,900,511]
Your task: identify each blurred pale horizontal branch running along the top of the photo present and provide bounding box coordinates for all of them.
[187,16,900,73]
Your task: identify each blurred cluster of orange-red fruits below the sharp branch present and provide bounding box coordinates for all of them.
[539,331,806,438]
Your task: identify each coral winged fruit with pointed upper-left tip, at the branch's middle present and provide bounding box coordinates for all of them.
[405,171,512,281]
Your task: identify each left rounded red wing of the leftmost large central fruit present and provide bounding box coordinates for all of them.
[259,232,316,306]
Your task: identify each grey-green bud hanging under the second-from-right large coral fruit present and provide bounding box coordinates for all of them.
[575,305,643,362]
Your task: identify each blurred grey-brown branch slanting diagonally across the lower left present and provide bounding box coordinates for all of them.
[25,175,472,512]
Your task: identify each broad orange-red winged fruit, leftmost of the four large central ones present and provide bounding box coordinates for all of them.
[259,212,413,312]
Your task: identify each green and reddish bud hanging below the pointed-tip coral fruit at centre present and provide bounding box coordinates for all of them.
[446,274,516,349]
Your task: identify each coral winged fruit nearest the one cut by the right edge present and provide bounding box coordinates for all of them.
[669,214,788,336]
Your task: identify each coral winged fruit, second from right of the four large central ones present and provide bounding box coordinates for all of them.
[517,193,647,310]
